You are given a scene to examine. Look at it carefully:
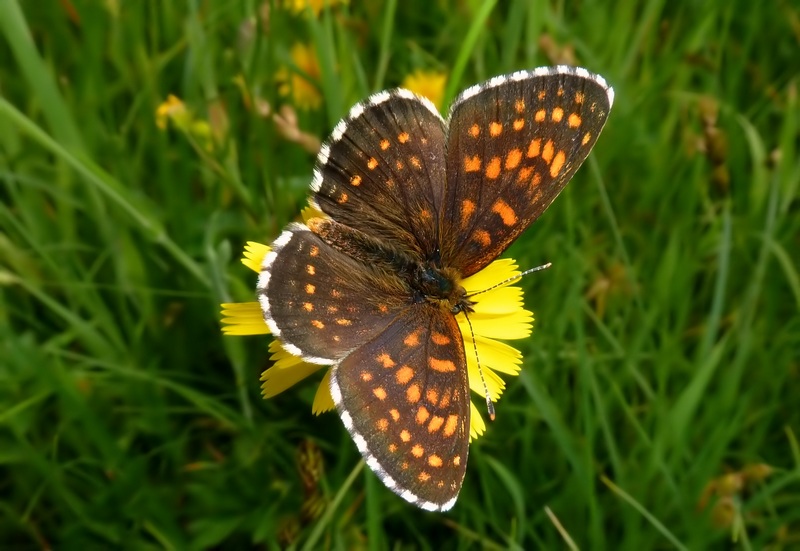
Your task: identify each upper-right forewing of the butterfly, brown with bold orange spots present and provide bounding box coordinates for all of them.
[440,66,614,276]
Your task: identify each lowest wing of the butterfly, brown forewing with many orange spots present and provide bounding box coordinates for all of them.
[331,304,470,510]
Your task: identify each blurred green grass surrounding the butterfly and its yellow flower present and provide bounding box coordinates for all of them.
[0,0,800,549]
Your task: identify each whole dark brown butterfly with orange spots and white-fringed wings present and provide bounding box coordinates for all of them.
[257,66,614,511]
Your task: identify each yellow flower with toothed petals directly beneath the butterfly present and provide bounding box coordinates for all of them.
[222,235,533,439]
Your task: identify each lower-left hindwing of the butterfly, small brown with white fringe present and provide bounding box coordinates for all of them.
[257,224,409,364]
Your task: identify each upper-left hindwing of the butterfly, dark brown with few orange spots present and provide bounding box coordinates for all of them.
[312,90,445,264]
